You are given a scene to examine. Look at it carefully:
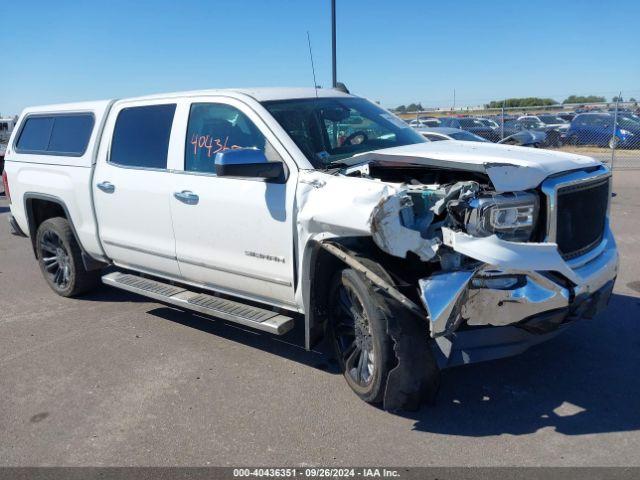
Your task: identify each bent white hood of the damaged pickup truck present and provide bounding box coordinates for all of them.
[353,140,601,192]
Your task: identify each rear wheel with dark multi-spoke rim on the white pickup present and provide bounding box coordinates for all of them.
[36,217,100,297]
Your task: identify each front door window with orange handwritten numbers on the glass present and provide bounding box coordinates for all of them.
[184,103,277,173]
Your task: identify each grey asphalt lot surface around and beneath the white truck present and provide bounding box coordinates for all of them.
[0,171,640,466]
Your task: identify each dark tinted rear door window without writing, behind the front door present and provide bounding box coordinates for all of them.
[110,104,176,168]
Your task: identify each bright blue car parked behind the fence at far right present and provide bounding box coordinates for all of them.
[565,113,640,148]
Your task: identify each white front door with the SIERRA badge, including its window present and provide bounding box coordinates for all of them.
[171,97,297,307]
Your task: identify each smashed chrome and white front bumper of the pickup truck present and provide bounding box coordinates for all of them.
[419,226,618,365]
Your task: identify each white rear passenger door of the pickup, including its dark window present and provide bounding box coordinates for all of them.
[93,101,180,277]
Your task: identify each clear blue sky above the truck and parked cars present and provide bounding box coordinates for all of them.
[0,0,640,114]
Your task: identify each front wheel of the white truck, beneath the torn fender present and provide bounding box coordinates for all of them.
[329,268,396,404]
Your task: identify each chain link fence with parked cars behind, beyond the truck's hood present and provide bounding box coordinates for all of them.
[400,101,640,169]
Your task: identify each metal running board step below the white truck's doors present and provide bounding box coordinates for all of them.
[102,272,293,335]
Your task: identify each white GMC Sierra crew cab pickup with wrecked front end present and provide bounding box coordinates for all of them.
[3,89,618,409]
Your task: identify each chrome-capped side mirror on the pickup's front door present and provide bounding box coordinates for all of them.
[214,148,284,180]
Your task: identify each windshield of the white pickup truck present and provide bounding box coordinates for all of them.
[263,98,427,169]
